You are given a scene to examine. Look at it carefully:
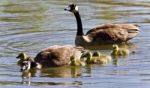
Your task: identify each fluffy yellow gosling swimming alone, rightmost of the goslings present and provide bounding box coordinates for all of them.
[111,44,130,56]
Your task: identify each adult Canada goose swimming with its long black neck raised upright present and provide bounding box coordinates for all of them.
[64,4,139,46]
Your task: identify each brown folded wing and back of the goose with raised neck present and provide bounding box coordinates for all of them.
[86,24,139,42]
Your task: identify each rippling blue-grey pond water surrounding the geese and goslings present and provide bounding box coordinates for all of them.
[0,0,150,88]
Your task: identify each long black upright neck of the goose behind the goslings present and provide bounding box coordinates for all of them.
[74,12,84,36]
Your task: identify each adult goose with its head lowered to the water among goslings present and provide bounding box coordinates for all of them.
[17,45,85,70]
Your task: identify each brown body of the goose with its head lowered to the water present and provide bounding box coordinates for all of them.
[35,46,85,67]
